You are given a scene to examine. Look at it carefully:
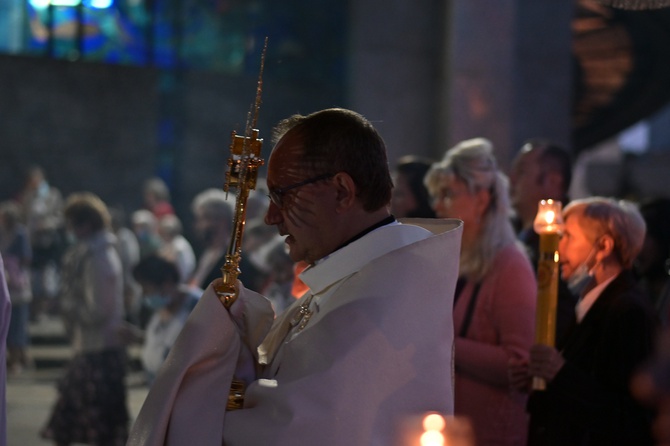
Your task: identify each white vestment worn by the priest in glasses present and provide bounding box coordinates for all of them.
[128,219,462,446]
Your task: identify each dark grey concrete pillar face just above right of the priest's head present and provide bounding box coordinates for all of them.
[349,0,446,165]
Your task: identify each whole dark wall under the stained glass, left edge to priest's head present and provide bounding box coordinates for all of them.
[0,56,345,233]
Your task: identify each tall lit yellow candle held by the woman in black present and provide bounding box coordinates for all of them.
[533,200,563,390]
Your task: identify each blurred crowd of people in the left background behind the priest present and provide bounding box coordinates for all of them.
[0,167,302,445]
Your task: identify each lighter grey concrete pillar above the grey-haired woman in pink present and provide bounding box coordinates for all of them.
[440,0,573,170]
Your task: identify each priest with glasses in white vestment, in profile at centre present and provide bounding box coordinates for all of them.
[129,109,461,446]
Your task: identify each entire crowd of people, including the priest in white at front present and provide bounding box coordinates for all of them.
[0,109,670,446]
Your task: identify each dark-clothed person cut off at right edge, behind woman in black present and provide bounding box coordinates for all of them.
[635,198,670,327]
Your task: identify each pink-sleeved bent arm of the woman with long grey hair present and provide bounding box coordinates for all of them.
[455,251,537,386]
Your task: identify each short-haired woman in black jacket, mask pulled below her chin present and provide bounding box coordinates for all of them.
[511,197,657,446]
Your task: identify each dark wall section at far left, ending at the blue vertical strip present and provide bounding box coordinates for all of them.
[0,56,157,211]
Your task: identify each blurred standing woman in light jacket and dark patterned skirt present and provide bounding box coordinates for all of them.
[42,192,128,445]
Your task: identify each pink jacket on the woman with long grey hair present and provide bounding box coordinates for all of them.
[454,245,537,446]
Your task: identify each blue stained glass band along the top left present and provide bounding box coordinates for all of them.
[0,0,347,84]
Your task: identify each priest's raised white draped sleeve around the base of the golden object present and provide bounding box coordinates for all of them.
[127,285,274,446]
